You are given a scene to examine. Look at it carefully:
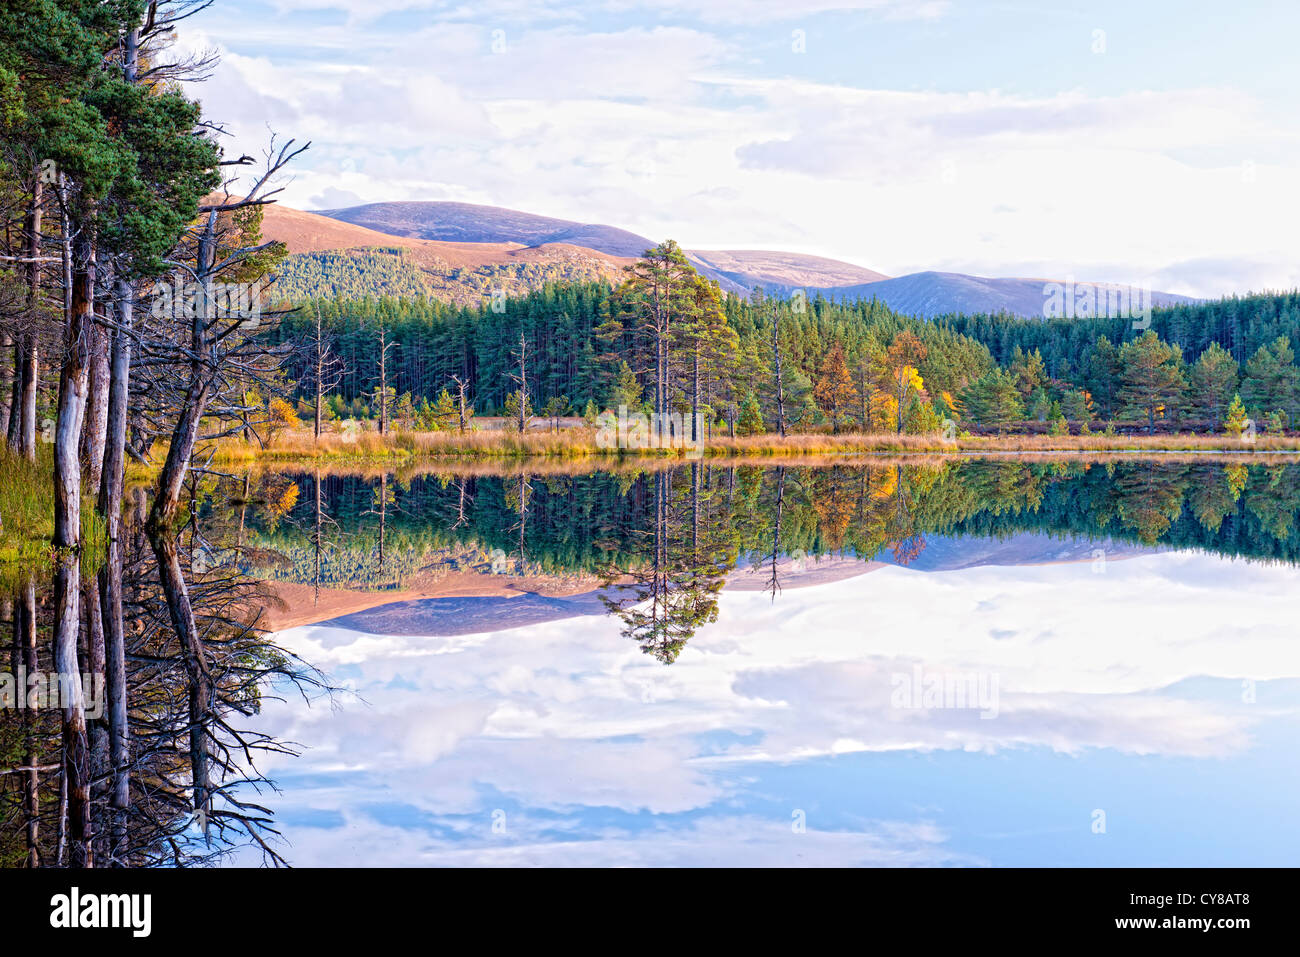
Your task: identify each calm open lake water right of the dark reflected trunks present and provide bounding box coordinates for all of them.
[226,462,1300,866]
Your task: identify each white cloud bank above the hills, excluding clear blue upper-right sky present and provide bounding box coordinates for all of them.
[180,0,1300,295]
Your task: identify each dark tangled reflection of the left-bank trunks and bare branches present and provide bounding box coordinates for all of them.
[0,490,322,867]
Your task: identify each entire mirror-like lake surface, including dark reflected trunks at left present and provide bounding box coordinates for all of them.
[10,458,1300,866]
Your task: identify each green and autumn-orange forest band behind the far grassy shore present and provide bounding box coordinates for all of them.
[272,242,1300,434]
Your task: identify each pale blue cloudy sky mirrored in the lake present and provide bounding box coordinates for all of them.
[228,540,1300,866]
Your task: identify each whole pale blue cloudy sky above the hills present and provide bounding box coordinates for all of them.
[179,0,1300,296]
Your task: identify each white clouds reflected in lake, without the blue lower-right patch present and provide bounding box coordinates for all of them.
[248,553,1300,865]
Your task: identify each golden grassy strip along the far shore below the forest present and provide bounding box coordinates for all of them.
[213,428,1300,464]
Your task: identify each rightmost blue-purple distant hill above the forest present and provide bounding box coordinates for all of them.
[809,272,1199,319]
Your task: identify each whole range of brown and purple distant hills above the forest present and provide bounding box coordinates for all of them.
[279,202,1199,319]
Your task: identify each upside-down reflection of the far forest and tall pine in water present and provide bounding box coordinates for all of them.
[233,460,1300,663]
